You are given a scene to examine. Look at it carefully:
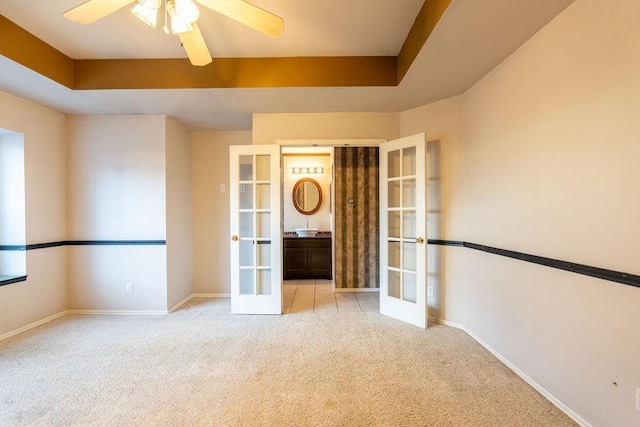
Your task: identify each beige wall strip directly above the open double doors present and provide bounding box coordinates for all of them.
[253,113,400,144]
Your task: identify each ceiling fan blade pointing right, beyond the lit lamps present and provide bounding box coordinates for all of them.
[196,0,284,37]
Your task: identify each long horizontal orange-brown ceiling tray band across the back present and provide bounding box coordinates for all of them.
[73,56,397,90]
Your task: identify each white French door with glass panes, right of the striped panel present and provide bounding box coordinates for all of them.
[380,134,427,328]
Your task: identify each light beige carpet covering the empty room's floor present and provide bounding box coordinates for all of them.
[0,299,574,426]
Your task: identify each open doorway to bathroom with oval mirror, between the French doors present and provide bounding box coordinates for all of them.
[281,141,379,313]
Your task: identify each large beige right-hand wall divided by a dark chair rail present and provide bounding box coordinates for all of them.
[463,0,640,426]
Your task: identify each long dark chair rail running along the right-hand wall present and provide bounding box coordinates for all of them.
[428,240,640,288]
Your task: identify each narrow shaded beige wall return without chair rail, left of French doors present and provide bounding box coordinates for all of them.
[166,118,193,308]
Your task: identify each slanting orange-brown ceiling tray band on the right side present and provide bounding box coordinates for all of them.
[397,0,451,84]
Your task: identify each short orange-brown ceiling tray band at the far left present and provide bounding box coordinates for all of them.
[0,15,73,88]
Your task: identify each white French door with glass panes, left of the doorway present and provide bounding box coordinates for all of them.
[229,145,282,314]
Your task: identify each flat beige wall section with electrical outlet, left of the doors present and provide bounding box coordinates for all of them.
[67,116,167,311]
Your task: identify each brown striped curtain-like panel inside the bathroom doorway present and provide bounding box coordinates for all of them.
[334,147,380,288]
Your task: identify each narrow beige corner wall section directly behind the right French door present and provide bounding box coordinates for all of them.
[400,96,465,324]
